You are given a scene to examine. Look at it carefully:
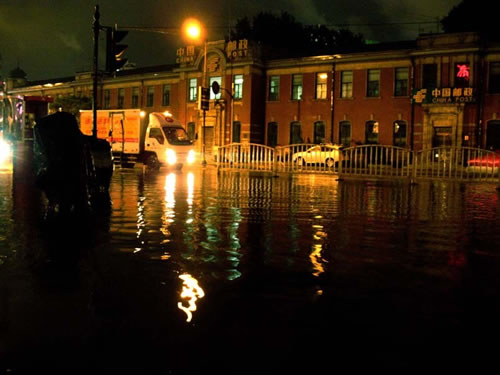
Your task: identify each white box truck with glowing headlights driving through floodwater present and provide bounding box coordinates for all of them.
[80,109,196,169]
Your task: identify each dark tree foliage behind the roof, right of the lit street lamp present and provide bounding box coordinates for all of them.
[230,12,364,58]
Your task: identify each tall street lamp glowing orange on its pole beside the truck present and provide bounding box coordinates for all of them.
[182,18,209,166]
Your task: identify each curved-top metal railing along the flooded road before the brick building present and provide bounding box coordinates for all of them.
[215,143,500,182]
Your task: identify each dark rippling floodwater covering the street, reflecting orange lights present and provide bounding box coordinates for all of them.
[0,155,500,374]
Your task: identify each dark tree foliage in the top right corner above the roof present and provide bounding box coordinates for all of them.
[441,0,500,40]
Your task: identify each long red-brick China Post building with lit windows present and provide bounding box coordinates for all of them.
[5,33,500,153]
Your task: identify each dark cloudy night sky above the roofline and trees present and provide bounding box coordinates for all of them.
[0,0,460,81]
